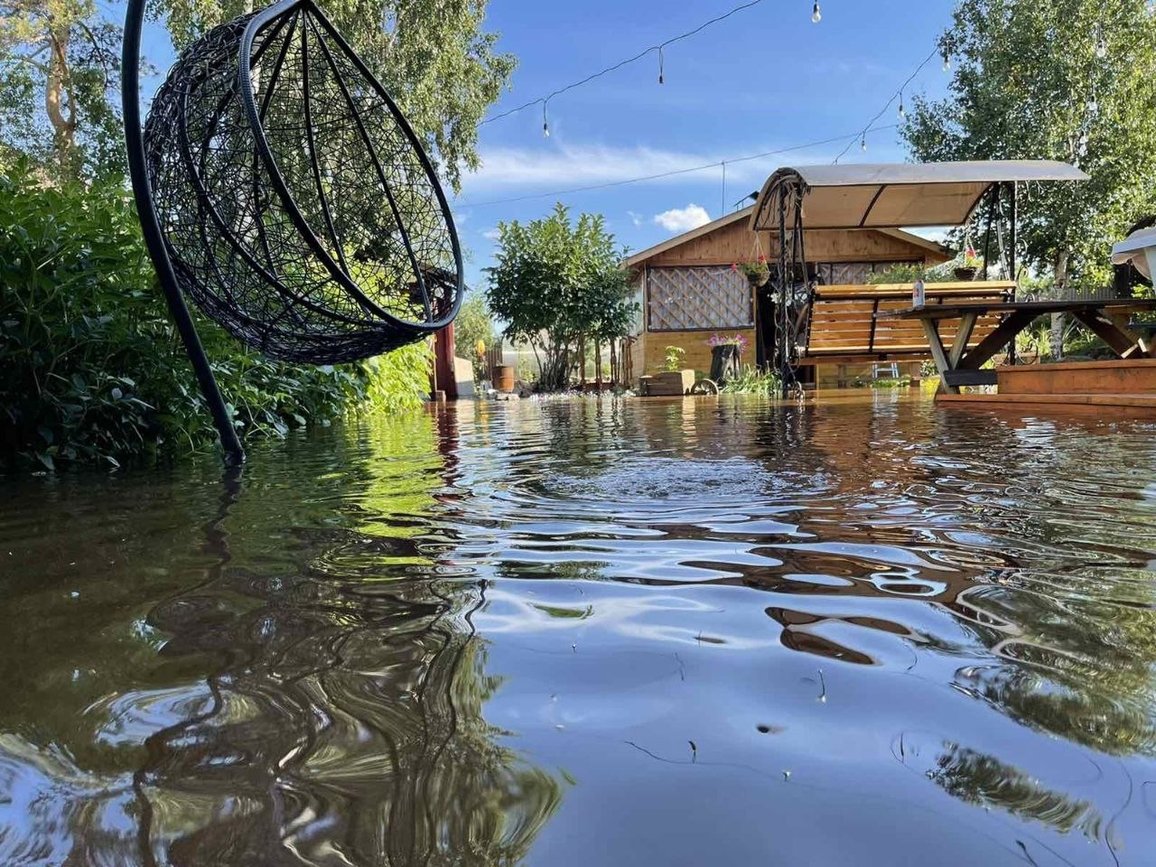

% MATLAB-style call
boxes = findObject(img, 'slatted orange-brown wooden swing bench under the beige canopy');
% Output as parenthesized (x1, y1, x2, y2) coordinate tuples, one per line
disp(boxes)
(800, 281, 1015, 364)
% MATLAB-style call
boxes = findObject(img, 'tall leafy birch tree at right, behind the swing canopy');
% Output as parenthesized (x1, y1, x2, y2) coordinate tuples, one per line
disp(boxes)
(903, 0, 1156, 286)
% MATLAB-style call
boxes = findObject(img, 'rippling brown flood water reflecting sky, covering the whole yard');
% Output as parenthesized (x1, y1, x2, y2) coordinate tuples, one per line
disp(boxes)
(0, 392, 1156, 867)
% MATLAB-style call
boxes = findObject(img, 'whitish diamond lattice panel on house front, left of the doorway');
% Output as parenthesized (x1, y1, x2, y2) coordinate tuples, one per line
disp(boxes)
(646, 265, 754, 331)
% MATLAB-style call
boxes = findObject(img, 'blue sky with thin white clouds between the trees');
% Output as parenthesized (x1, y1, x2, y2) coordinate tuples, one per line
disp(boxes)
(137, 0, 954, 288)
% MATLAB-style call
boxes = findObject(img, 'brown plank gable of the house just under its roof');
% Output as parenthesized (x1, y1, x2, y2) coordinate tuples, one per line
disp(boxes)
(646, 220, 948, 267)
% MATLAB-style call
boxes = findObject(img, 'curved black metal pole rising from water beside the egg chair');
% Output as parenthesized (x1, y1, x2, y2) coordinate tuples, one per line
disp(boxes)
(120, 0, 245, 467)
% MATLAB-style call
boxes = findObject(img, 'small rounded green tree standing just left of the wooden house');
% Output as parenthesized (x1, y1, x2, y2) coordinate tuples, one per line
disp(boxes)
(487, 203, 637, 391)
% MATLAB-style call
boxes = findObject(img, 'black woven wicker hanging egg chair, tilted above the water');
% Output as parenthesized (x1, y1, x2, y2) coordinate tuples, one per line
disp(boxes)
(134, 0, 462, 364)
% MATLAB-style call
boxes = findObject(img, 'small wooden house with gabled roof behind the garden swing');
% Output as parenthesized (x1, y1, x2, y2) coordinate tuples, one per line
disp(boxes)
(627, 206, 953, 387)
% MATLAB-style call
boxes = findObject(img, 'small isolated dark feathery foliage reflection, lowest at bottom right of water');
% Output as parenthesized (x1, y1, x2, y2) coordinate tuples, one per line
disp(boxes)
(927, 743, 1104, 839)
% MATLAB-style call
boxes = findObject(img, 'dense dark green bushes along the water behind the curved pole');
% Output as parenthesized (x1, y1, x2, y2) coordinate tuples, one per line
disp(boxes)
(0, 165, 429, 469)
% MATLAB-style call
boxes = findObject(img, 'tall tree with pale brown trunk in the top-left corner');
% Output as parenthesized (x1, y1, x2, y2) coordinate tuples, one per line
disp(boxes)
(0, 0, 120, 177)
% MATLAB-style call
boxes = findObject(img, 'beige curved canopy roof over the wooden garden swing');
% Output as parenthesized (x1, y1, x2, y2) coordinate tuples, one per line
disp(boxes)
(750, 160, 1088, 231)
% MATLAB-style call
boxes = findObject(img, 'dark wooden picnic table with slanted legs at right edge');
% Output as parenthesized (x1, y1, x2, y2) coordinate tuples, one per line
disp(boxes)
(876, 298, 1156, 394)
